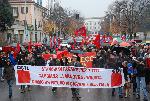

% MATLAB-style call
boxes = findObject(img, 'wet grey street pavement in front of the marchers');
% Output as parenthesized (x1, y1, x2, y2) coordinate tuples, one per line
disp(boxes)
(0, 83, 149, 101)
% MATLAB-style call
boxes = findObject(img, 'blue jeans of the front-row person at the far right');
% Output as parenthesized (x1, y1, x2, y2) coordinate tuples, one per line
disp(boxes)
(136, 77, 147, 99)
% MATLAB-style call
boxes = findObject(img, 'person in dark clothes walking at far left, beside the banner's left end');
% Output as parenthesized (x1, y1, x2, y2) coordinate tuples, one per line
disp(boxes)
(3, 60, 15, 99)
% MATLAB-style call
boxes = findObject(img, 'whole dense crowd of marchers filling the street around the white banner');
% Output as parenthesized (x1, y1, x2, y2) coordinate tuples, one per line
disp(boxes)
(0, 41, 150, 101)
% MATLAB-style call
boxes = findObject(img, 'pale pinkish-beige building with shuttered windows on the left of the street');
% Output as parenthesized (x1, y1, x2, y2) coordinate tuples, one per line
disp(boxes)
(9, 0, 48, 43)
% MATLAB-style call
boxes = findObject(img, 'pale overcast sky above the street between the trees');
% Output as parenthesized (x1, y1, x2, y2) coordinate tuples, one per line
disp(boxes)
(43, 0, 115, 17)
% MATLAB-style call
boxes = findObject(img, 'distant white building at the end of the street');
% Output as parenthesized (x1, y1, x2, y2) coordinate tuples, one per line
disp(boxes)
(84, 17, 102, 34)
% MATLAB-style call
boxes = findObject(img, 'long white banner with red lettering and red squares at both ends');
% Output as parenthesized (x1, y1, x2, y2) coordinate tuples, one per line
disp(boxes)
(14, 65, 124, 88)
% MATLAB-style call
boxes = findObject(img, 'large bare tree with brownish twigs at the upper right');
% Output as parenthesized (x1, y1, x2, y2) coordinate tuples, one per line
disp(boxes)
(101, 0, 150, 39)
